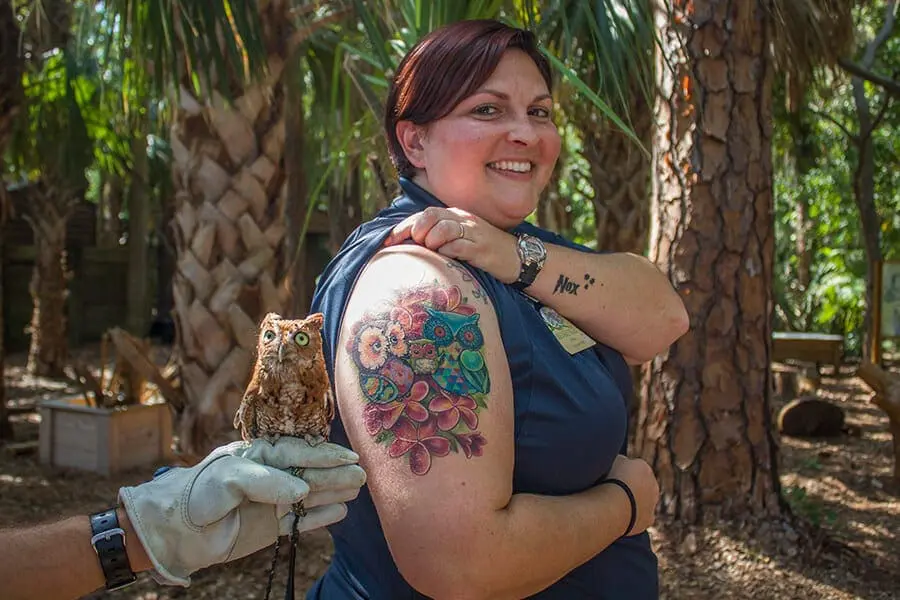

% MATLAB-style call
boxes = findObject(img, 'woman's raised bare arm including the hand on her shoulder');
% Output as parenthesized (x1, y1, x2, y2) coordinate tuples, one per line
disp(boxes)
(387, 208, 689, 363)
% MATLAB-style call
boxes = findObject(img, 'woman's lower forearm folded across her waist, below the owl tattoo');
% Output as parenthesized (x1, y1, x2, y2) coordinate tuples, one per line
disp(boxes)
(398, 485, 631, 600)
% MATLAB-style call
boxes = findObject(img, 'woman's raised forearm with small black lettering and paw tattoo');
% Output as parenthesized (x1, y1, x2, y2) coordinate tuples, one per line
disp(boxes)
(526, 244, 688, 362)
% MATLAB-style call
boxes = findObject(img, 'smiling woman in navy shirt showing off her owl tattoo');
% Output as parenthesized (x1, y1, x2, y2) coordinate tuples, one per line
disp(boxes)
(309, 21, 687, 600)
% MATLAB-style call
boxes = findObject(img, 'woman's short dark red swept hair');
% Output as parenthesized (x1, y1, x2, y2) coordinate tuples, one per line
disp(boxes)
(384, 19, 553, 177)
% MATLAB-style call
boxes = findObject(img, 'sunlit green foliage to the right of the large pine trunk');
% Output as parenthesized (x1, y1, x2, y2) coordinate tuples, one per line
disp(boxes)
(773, 1, 900, 354)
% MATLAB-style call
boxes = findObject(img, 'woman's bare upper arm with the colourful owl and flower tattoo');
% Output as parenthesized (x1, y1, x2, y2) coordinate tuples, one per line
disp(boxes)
(335, 245, 513, 500)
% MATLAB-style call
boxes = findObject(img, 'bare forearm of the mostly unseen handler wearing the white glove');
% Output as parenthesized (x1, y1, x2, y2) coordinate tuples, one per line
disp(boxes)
(0, 509, 152, 600)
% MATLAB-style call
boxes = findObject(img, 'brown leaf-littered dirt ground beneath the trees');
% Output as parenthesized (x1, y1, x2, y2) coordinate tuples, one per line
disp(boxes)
(0, 347, 900, 600)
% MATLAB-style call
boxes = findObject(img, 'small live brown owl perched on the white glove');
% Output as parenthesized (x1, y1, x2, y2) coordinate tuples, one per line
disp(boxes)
(234, 313, 334, 445)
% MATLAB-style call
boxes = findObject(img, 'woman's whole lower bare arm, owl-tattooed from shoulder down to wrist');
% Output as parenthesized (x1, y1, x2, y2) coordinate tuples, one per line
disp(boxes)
(335, 246, 640, 598)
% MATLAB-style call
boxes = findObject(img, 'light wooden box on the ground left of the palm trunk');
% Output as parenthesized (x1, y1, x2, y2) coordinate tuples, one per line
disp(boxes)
(39, 397, 172, 475)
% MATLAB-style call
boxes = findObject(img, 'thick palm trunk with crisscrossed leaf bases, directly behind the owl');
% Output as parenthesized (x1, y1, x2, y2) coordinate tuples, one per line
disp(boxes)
(170, 11, 289, 456)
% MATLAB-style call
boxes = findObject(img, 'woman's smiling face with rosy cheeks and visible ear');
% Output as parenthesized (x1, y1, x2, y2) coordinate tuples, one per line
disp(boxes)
(398, 50, 560, 229)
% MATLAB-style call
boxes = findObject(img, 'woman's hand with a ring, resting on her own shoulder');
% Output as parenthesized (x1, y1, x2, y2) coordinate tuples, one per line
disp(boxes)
(384, 207, 521, 283)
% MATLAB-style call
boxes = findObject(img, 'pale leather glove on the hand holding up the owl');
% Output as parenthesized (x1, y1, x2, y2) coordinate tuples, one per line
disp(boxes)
(119, 437, 366, 587)
